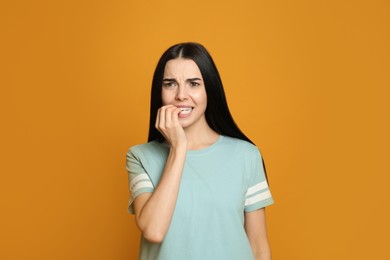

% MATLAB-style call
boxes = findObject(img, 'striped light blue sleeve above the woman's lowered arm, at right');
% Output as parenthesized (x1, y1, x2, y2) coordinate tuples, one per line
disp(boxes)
(244, 149, 274, 212)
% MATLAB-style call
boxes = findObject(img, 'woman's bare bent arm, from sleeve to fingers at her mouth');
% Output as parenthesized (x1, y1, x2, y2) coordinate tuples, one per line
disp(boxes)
(134, 106, 187, 243)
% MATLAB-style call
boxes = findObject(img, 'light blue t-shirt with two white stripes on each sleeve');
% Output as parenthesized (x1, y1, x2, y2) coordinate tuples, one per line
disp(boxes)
(127, 135, 273, 260)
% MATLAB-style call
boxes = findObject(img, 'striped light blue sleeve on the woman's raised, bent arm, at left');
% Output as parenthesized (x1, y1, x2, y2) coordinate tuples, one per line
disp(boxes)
(126, 149, 154, 214)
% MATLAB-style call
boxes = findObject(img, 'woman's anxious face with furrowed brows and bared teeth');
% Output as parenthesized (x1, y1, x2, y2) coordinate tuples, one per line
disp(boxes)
(161, 58, 207, 128)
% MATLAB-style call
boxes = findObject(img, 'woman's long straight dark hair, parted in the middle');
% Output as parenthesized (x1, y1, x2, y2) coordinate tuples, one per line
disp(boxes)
(148, 42, 253, 144)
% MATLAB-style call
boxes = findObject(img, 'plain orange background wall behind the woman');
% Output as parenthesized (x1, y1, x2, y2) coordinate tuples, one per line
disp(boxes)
(0, 0, 390, 260)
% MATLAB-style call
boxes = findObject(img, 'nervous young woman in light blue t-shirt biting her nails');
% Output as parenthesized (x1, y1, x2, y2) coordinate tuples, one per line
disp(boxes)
(127, 43, 273, 260)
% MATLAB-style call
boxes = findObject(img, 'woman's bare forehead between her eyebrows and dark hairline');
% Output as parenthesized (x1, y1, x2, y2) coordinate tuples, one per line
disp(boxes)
(164, 58, 202, 78)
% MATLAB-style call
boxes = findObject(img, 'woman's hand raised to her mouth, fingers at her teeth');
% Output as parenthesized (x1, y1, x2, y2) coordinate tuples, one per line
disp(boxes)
(155, 105, 187, 148)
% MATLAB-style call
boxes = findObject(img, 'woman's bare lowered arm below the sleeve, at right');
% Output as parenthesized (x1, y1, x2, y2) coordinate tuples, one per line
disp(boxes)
(245, 208, 271, 260)
